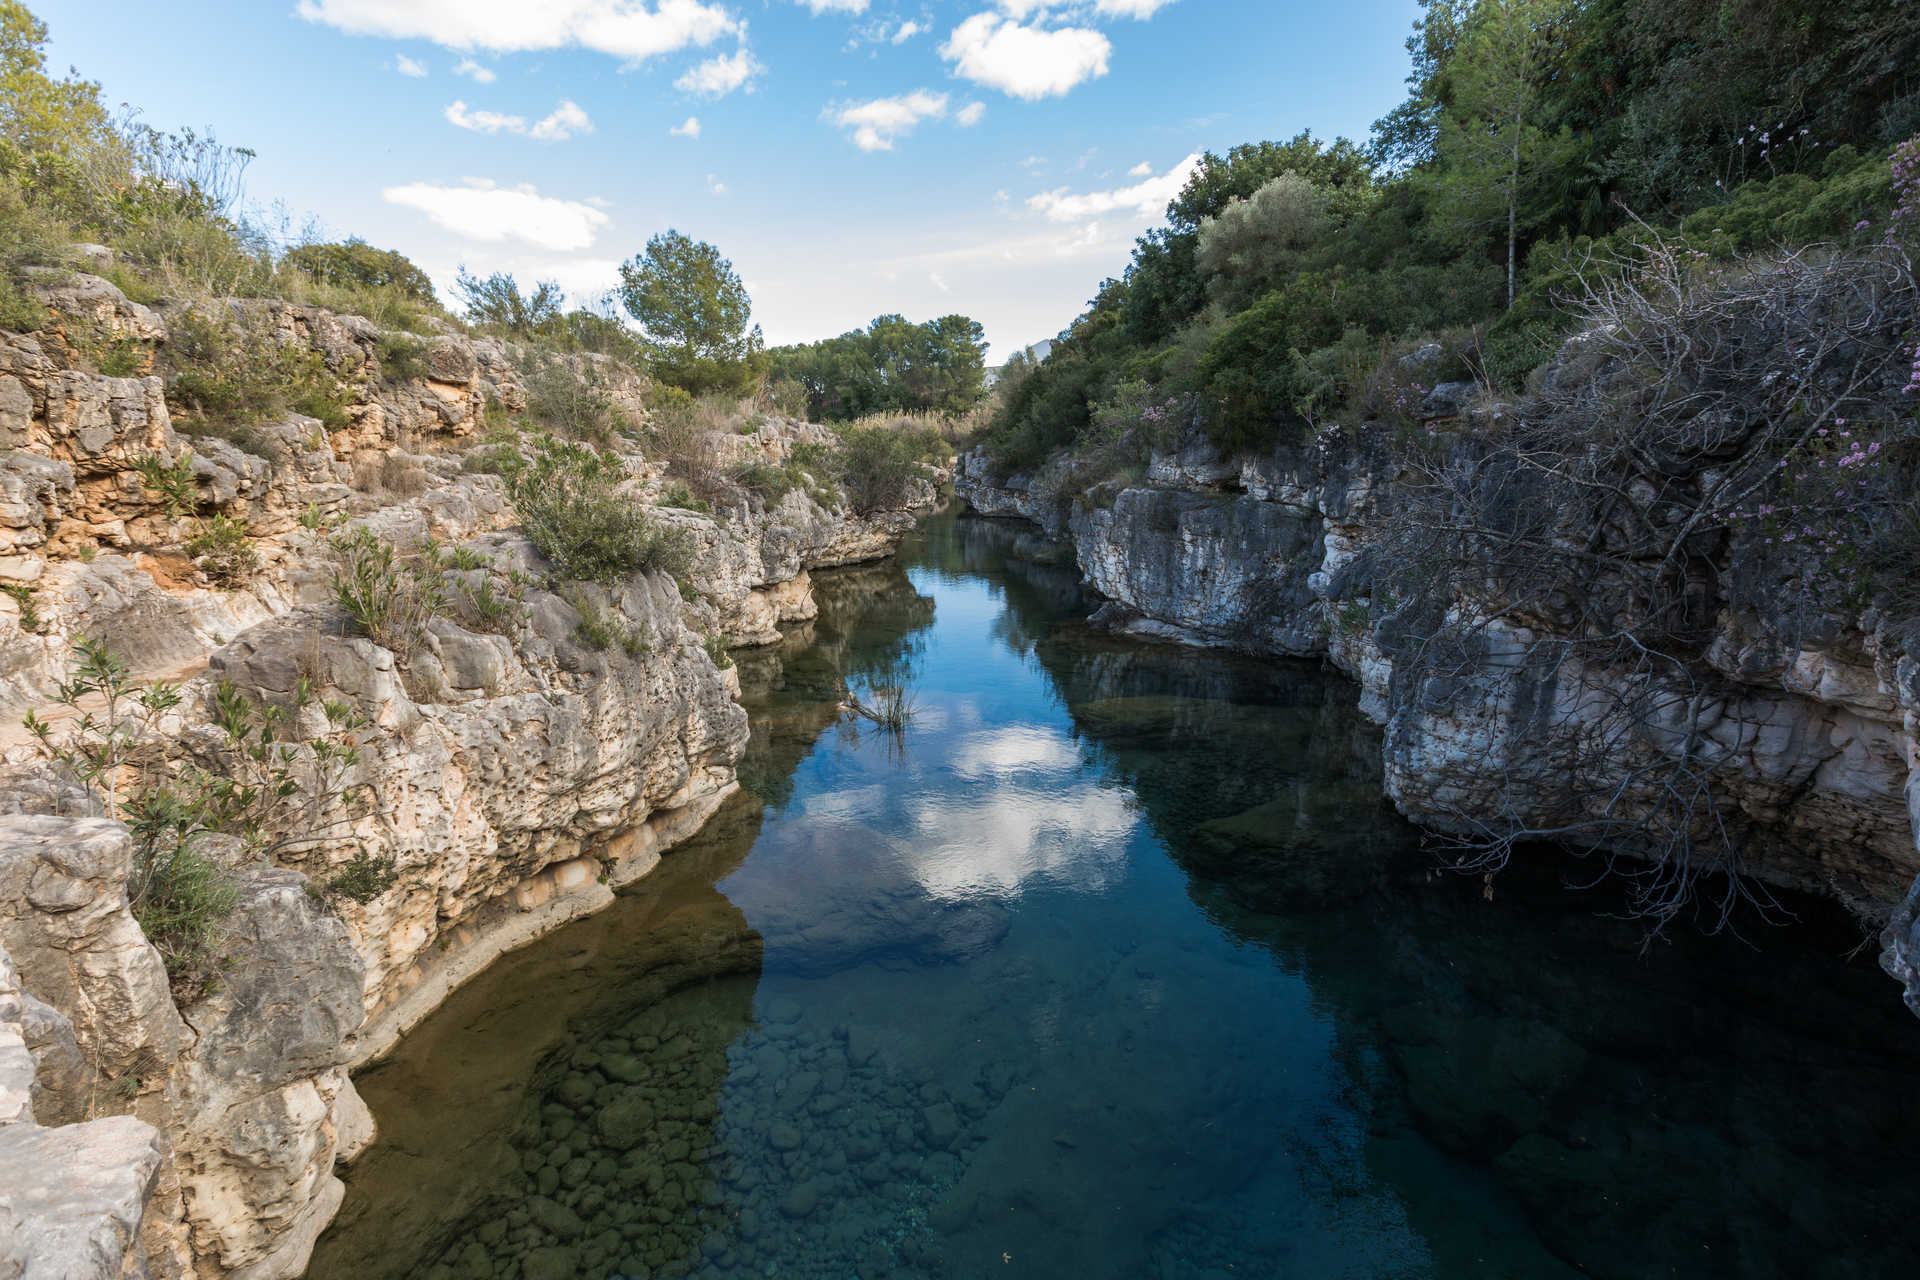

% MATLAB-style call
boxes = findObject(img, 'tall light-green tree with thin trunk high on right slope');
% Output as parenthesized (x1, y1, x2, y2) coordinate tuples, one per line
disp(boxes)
(1427, 0, 1572, 309)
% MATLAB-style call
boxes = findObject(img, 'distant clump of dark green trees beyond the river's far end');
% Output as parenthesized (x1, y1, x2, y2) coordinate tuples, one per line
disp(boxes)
(768, 315, 987, 422)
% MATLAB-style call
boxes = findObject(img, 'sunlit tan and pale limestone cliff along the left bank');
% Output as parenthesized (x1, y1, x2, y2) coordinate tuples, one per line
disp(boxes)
(0, 274, 936, 1280)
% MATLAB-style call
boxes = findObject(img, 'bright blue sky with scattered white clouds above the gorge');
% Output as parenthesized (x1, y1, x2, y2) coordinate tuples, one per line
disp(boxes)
(29, 0, 1417, 359)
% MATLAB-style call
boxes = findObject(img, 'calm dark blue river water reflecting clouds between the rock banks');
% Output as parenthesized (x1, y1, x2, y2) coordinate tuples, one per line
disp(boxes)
(315, 518, 1920, 1280)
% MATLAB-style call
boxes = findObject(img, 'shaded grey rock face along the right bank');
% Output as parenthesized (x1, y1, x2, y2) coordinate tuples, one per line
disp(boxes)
(956, 432, 1920, 1013)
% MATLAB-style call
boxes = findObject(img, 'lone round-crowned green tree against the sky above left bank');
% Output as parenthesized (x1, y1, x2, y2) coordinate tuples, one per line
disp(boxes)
(620, 230, 760, 393)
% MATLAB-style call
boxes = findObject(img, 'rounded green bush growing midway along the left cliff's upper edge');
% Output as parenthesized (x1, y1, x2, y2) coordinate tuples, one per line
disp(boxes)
(505, 434, 693, 583)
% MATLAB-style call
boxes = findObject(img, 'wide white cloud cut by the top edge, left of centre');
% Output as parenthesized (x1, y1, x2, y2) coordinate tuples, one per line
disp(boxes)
(296, 0, 745, 63)
